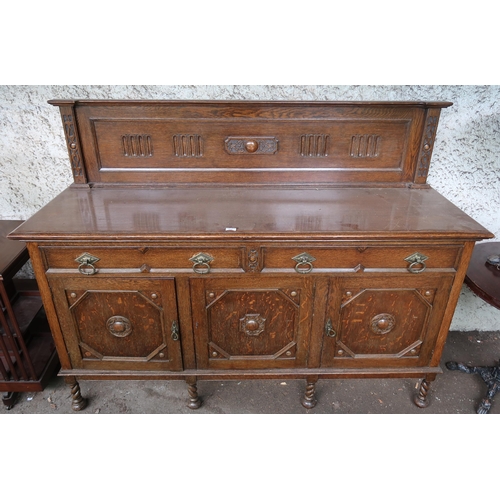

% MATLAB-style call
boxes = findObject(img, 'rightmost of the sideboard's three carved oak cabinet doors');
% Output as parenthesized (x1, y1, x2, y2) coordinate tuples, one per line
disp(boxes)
(321, 276, 453, 368)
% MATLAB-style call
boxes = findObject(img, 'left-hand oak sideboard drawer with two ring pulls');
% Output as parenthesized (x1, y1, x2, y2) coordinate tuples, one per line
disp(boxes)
(41, 246, 244, 274)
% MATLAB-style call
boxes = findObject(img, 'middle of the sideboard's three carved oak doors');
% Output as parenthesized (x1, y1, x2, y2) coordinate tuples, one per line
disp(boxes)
(190, 277, 312, 369)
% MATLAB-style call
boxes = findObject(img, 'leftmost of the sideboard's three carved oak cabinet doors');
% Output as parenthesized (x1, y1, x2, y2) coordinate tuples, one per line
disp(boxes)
(49, 276, 182, 370)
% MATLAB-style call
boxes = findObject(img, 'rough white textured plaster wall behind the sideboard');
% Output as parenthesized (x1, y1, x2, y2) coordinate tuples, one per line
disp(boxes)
(0, 85, 500, 331)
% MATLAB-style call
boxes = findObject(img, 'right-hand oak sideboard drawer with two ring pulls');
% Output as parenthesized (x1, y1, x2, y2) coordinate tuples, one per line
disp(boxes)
(262, 245, 462, 274)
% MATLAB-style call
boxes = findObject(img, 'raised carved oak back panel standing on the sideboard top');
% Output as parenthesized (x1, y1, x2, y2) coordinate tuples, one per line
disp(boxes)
(50, 101, 450, 186)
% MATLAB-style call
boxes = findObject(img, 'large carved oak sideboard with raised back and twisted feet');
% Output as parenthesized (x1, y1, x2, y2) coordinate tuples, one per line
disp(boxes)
(6, 100, 493, 410)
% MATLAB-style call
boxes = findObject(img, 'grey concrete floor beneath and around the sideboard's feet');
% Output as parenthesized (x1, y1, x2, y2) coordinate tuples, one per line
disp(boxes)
(0, 332, 500, 415)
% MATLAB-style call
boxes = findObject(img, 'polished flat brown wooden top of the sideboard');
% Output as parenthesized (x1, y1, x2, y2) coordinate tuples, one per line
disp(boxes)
(11, 187, 492, 241)
